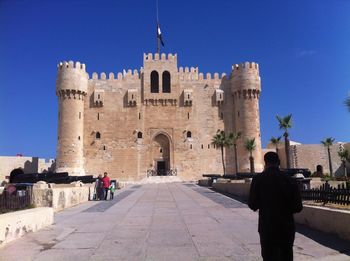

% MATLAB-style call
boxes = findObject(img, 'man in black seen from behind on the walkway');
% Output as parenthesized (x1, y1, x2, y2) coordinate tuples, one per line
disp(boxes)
(248, 152, 303, 261)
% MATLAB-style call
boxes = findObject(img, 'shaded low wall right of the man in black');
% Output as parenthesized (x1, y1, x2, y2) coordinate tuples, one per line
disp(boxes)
(294, 205, 350, 241)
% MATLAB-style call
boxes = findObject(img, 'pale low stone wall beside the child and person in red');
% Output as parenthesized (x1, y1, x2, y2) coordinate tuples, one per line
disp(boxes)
(33, 182, 95, 212)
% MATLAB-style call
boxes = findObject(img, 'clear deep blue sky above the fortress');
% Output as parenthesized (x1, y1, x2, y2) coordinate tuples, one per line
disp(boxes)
(0, 0, 350, 157)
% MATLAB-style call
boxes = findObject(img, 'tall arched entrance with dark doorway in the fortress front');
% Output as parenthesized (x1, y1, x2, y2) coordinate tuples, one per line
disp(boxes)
(152, 133, 171, 176)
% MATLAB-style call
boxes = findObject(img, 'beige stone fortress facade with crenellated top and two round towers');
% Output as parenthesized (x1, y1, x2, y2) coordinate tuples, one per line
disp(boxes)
(56, 54, 263, 181)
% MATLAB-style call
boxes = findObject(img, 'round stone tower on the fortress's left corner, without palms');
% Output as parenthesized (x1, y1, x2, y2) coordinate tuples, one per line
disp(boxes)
(56, 61, 89, 176)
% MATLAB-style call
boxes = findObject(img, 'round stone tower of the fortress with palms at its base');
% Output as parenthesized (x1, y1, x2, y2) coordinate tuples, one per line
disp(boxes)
(231, 62, 264, 172)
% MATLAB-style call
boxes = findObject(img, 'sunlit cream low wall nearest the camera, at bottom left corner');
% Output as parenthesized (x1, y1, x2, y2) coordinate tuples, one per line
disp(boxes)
(0, 208, 54, 247)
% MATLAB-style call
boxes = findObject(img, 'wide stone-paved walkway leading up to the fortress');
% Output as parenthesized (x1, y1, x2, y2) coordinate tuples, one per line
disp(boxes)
(0, 183, 350, 261)
